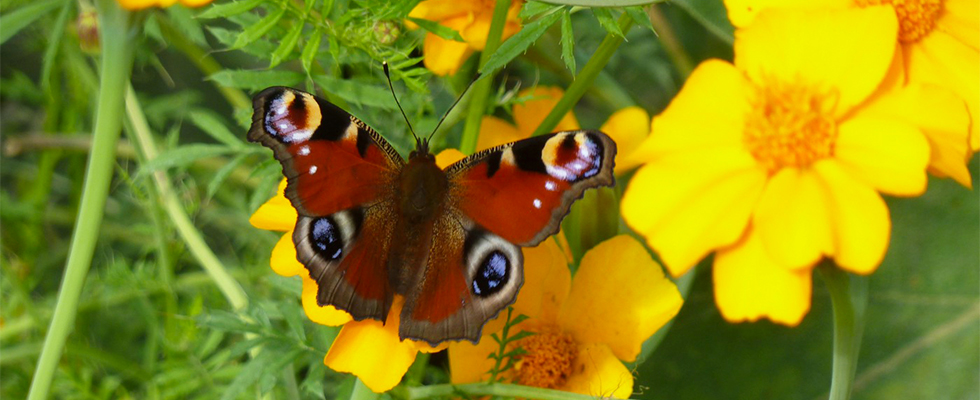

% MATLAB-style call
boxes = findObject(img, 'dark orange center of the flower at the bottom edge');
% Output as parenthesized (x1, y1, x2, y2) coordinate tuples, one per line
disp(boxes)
(514, 331, 578, 389)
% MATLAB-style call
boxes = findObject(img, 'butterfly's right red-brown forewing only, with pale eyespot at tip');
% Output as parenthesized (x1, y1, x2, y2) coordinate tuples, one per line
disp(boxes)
(446, 131, 616, 247)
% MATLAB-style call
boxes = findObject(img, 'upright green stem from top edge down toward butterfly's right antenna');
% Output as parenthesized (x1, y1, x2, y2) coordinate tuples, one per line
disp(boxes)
(459, 0, 510, 154)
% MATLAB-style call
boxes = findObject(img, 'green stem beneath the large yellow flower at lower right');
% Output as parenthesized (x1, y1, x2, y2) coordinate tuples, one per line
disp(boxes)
(818, 263, 868, 400)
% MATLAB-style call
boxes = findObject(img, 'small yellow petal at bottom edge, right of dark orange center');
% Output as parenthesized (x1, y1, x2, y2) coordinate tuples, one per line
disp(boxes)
(559, 343, 633, 399)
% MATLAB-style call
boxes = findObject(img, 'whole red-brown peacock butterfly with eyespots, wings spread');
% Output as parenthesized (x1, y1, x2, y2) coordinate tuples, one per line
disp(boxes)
(248, 87, 616, 346)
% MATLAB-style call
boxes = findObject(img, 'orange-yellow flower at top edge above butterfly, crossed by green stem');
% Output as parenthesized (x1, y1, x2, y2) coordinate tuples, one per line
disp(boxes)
(408, 0, 521, 76)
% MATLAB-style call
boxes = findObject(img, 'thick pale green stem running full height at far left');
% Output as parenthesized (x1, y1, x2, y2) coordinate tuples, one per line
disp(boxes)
(28, 0, 137, 400)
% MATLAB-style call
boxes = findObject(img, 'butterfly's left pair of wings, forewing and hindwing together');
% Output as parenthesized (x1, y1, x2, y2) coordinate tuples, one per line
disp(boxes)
(248, 87, 404, 321)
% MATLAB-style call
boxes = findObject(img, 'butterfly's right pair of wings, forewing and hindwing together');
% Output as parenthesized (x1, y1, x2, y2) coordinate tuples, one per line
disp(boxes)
(400, 131, 616, 344)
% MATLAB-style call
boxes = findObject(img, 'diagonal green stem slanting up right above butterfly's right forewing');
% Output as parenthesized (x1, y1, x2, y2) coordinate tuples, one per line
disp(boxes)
(531, 13, 633, 136)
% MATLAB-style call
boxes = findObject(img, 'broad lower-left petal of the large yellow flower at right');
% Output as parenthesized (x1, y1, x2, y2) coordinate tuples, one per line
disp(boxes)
(621, 147, 767, 276)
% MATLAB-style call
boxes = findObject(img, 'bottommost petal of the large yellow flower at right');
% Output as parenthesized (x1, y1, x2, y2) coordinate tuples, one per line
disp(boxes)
(712, 229, 813, 326)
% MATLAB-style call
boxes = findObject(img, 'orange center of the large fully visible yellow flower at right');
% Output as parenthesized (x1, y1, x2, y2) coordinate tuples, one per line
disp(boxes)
(743, 78, 837, 173)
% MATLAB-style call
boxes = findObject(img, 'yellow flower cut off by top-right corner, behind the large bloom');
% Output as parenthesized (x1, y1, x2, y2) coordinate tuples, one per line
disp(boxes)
(725, 0, 980, 187)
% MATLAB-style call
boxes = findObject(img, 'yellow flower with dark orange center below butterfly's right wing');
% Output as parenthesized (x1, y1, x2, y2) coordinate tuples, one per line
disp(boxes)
(449, 235, 683, 398)
